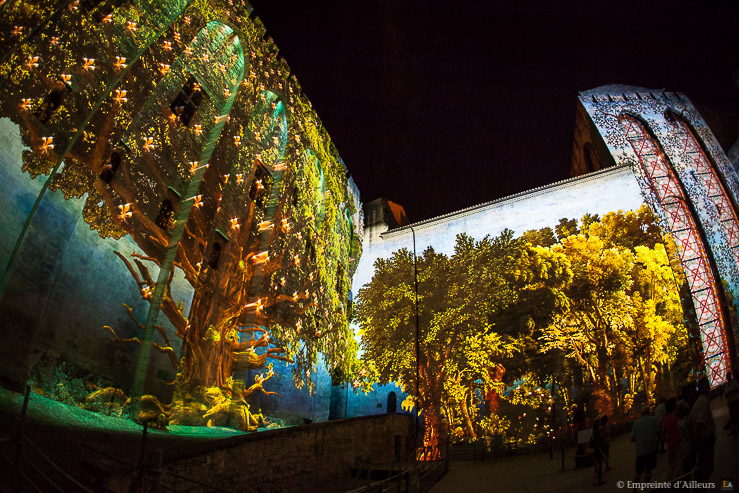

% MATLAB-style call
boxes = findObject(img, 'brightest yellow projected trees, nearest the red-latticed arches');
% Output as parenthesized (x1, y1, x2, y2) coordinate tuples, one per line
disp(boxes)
(541, 207, 687, 414)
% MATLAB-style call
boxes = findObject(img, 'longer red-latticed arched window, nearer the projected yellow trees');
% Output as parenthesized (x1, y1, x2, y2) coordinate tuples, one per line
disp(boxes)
(619, 115, 728, 386)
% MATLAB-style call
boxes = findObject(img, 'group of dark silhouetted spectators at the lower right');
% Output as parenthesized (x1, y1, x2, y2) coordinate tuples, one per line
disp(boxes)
(631, 372, 739, 482)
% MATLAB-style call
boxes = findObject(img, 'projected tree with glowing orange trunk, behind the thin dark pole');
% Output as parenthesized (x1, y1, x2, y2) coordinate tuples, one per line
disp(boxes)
(356, 232, 516, 456)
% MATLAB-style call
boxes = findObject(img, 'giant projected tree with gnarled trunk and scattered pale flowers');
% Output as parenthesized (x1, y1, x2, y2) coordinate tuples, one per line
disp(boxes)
(0, 0, 360, 429)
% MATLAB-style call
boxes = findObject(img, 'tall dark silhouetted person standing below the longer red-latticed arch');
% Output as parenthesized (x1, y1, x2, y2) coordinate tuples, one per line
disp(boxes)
(688, 377, 716, 482)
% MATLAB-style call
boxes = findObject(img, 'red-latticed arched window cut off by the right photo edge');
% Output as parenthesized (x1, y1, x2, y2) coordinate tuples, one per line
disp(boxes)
(665, 111, 739, 264)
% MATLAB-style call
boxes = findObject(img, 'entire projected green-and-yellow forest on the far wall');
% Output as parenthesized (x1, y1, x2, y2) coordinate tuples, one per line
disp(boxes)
(356, 206, 700, 448)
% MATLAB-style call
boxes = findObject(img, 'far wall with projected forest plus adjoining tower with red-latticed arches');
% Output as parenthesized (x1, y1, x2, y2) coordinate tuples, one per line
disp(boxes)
(348, 86, 739, 448)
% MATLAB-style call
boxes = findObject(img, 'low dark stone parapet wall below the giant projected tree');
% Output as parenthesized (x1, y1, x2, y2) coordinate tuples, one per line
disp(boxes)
(162, 414, 413, 492)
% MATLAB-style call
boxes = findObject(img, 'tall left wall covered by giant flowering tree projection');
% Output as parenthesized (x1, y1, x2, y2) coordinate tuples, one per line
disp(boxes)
(0, 0, 362, 422)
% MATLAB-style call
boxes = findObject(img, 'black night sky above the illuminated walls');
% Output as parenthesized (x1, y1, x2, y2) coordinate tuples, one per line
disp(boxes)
(251, 0, 739, 222)
